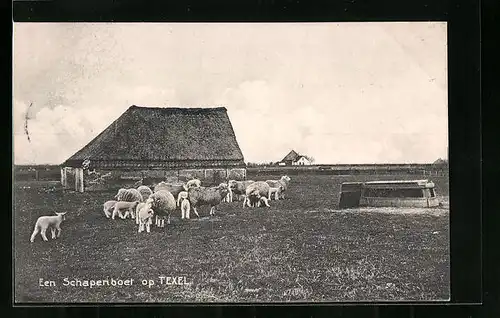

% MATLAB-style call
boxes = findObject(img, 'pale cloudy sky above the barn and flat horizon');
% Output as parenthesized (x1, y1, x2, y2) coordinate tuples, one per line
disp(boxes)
(13, 22, 448, 164)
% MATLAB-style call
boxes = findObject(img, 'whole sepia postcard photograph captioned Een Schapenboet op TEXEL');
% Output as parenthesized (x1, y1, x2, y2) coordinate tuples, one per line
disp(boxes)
(12, 22, 450, 304)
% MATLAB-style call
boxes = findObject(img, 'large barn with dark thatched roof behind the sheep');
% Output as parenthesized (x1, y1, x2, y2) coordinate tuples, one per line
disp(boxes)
(61, 105, 245, 191)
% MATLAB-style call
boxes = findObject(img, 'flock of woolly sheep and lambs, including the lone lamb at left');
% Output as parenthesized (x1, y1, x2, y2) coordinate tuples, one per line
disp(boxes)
(30, 175, 290, 242)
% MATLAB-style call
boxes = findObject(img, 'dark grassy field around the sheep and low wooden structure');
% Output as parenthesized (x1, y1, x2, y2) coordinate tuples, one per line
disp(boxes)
(13, 175, 450, 302)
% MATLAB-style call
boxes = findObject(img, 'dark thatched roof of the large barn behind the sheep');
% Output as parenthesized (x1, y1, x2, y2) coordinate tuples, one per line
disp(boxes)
(63, 105, 244, 166)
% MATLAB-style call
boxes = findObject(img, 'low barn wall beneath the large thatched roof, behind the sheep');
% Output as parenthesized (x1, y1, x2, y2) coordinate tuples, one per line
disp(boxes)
(79, 168, 246, 191)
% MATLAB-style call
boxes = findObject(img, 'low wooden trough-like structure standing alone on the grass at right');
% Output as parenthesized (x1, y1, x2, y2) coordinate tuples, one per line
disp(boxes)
(339, 180, 439, 209)
